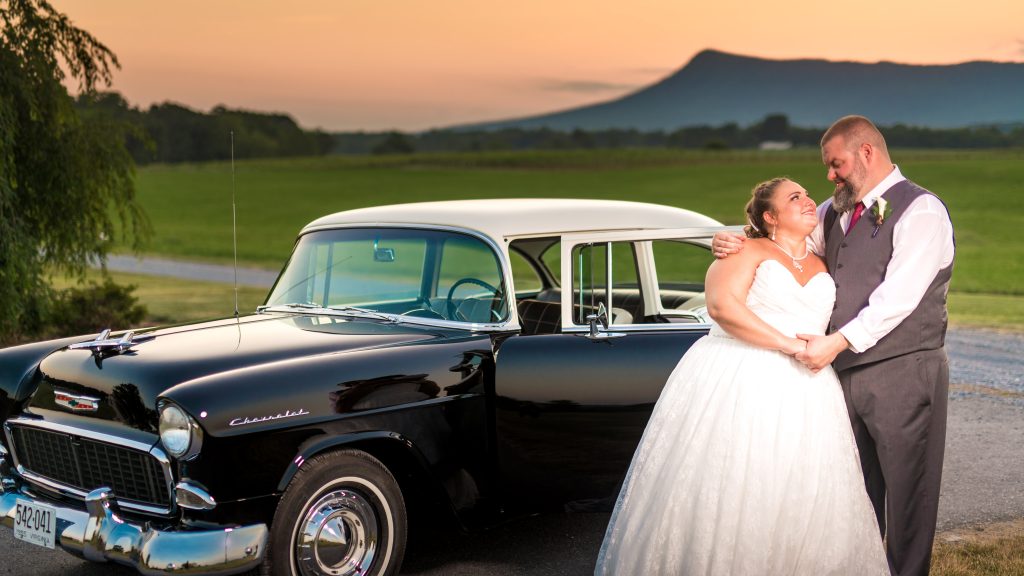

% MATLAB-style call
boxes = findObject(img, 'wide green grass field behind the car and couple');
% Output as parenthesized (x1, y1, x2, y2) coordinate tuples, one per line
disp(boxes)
(110, 150, 1024, 327)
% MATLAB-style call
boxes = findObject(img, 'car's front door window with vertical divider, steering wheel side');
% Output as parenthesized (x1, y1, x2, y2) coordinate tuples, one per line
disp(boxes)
(572, 242, 644, 325)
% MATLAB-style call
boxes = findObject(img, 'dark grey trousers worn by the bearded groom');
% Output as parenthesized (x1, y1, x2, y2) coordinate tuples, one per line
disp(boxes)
(839, 348, 949, 576)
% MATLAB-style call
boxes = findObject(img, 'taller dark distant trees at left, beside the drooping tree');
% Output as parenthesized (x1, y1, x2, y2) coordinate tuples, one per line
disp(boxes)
(76, 92, 334, 164)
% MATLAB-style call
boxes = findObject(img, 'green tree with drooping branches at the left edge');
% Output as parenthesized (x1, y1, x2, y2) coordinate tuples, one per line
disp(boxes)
(0, 0, 150, 342)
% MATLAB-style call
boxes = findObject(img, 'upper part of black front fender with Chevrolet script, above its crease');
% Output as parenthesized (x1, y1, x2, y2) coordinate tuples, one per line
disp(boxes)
(161, 337, 490, 438)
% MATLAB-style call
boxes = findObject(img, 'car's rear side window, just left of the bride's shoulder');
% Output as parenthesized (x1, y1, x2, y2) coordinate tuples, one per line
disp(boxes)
(651, 240, 715, 319)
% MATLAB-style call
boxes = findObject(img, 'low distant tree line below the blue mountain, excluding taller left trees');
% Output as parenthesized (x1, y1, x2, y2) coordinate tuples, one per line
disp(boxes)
(334, 114, 1024, 154)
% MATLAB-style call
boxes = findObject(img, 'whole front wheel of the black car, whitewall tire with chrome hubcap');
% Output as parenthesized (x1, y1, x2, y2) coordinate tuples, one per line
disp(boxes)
(263, 450, 408, 576)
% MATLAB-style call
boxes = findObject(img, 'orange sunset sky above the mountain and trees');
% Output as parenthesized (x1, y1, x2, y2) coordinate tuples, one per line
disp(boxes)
(61, 0, 1024, 130)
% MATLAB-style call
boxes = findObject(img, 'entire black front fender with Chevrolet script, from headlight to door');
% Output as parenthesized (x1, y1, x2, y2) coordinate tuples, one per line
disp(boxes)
(163, 335, 490, 516)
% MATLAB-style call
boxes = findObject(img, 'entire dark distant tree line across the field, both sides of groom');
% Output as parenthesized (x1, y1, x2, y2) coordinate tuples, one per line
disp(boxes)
(76, 92, 1024, 164)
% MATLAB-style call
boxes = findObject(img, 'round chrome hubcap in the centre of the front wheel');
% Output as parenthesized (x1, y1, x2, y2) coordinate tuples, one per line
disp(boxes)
(295, 490, 380, 576)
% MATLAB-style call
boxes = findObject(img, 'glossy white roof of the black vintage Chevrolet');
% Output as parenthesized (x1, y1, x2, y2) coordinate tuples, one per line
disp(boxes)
(302, 198, 722, 240)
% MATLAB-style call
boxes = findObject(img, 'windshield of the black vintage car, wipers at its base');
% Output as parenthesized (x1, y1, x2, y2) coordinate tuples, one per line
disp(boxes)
(262, 229, 509, 324)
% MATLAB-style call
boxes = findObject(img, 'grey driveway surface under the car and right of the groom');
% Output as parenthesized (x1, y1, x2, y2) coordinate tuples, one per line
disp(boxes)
(0, 330, 1024, 576)
